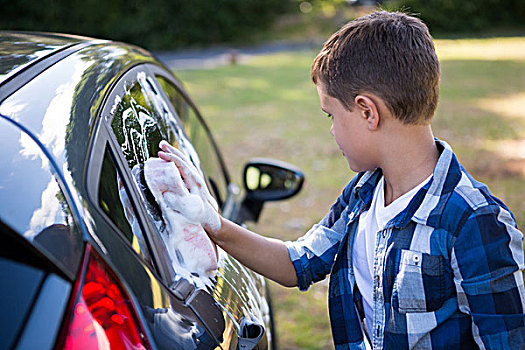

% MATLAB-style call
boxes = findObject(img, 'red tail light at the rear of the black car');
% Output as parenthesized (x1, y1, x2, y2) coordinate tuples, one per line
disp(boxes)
(60, 245, 149, 350)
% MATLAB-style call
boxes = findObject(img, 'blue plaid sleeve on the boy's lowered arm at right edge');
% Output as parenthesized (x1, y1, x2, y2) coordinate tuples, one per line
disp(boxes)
(451, 205, 525, 349)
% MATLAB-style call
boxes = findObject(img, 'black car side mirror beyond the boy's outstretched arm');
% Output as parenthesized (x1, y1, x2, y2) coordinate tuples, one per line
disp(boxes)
(237, 158, 304, 222)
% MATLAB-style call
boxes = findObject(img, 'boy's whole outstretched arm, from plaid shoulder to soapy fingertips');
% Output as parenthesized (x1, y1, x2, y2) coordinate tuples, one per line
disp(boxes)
(158, 141, 359, 290)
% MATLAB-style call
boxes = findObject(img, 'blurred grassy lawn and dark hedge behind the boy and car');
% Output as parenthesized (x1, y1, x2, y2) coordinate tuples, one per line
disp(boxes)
(0, 0, 525, 349)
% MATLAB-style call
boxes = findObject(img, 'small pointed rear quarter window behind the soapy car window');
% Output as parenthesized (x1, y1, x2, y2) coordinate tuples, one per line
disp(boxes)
(98, 148, 153, 266)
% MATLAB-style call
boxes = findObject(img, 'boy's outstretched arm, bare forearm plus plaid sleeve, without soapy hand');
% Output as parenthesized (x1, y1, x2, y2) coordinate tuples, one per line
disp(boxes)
(211, 176, 359, 290)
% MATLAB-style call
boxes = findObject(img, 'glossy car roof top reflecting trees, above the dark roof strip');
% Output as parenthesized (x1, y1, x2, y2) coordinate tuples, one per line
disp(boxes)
(0, 31, 93, 83)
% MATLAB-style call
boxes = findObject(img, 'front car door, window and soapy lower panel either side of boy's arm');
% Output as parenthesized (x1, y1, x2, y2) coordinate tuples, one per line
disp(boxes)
(152, 67, 272, 343)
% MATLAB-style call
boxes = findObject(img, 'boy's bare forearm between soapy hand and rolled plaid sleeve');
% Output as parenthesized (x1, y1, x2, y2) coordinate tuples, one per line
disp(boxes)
(207, 217, 297, 287)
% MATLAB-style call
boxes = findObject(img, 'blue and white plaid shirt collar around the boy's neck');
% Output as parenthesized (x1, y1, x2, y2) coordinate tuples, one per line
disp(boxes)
(355, 139, 461, 228)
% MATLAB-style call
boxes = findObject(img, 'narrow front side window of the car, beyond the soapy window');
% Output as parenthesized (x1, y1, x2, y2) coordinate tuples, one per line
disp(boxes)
(156, 75, 228, 205)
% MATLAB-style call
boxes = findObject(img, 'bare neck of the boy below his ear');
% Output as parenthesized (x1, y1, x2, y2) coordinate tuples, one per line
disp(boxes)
(380, 125, 439, 206)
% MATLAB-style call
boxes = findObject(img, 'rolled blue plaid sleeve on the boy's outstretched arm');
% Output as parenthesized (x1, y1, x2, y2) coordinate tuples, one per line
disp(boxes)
(285, 182, 352, 291)
